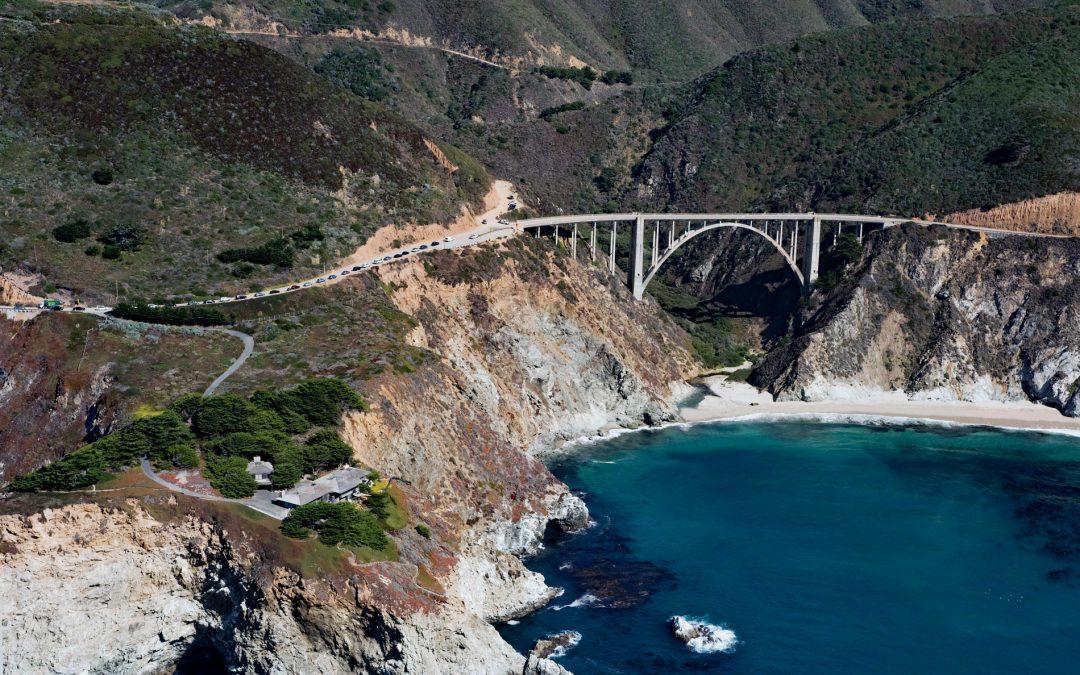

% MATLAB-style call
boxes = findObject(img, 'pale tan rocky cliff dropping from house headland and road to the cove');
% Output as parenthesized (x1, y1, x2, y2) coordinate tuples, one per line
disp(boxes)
(0, 235, 696, 673)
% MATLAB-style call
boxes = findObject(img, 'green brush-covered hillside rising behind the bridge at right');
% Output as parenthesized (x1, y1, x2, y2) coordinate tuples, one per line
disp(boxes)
(629, 8, 1080, 214)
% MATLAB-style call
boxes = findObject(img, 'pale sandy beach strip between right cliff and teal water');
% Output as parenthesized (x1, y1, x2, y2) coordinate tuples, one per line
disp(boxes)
(679, 376, 1080, 436)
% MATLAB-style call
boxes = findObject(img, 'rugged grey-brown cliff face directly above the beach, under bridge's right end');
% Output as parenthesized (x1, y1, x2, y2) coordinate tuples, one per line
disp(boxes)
(751, 226, 1080, 417)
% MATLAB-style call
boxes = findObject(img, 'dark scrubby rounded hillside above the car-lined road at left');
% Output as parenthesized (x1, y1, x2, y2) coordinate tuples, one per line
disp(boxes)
(0, 2, 489, 300)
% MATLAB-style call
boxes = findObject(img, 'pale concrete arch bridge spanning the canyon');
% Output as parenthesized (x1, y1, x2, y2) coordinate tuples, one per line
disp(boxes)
(517, 213, 1042, 299)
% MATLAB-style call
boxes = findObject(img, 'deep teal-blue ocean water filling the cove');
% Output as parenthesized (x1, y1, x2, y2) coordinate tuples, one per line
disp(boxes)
(500, 421, 1080, 675)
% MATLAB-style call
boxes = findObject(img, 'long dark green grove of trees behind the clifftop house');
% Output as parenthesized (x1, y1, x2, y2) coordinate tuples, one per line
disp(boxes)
(11, 378, 365, 498)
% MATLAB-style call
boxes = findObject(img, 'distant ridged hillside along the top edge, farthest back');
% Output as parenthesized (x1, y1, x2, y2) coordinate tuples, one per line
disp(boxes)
(159, 0, 1044, 79)
